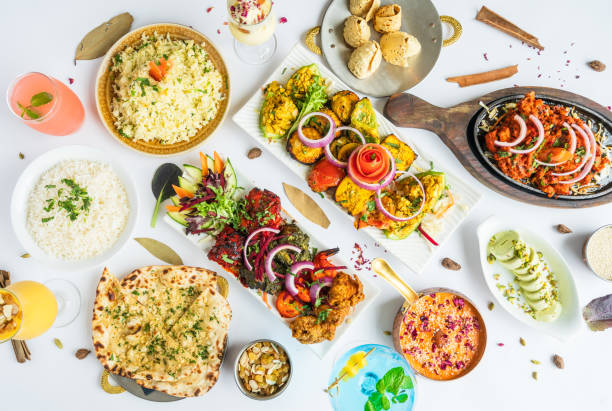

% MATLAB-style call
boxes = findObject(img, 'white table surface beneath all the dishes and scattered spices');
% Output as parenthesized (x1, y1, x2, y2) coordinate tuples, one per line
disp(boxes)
(0, 0, 612, 411)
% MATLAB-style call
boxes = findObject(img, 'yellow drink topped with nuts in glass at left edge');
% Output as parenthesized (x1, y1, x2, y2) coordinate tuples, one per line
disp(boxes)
(0, 281, 58, 343)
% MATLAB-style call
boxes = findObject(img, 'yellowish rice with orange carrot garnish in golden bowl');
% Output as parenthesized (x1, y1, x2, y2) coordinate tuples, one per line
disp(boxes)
(111, 34, 226, 144)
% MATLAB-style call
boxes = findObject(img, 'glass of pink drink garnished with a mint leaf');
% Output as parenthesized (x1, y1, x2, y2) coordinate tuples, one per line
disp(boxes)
(6, 73, 85, 136)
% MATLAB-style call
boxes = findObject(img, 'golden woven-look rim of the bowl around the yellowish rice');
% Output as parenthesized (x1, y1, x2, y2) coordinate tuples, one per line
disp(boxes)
(96, 23, 230, 156)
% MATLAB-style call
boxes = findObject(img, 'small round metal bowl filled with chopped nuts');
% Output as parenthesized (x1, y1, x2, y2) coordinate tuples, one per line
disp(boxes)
(238, 341, 290, 396)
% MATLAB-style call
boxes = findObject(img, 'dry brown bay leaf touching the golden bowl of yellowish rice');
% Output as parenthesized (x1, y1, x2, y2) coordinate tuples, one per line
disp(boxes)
(74, 13, 134, 60)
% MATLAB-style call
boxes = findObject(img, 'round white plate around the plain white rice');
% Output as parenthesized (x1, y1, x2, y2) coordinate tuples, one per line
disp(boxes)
(11, 146, 138, 271)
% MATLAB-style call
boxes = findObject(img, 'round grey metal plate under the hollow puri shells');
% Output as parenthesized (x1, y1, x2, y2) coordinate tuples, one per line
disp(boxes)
(321, 0, 442, 97)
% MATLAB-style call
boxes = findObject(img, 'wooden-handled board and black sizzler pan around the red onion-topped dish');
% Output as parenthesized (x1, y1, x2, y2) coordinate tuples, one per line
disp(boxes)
(384, 87, 612, 208)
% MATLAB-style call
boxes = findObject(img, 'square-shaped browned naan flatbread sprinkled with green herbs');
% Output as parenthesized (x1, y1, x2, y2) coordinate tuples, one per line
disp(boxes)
(92, 266, 231, 397)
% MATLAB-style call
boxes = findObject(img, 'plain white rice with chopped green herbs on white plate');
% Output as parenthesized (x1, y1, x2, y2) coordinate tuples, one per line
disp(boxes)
(26, 160, 130, 261)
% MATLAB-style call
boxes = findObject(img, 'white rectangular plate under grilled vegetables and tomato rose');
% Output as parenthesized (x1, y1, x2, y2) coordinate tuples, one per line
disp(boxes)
(233, 44, 480, 274)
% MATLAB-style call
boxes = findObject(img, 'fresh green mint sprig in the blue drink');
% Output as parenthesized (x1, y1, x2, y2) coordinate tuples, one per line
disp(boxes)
(364, 367, 414, 411)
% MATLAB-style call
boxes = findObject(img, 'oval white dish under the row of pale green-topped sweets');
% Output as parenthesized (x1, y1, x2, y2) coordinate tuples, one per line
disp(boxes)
(477, 216, 582, 341)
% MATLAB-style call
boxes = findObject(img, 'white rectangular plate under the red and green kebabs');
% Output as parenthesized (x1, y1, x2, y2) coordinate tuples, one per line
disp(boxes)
(164, 158, 380, 358)
